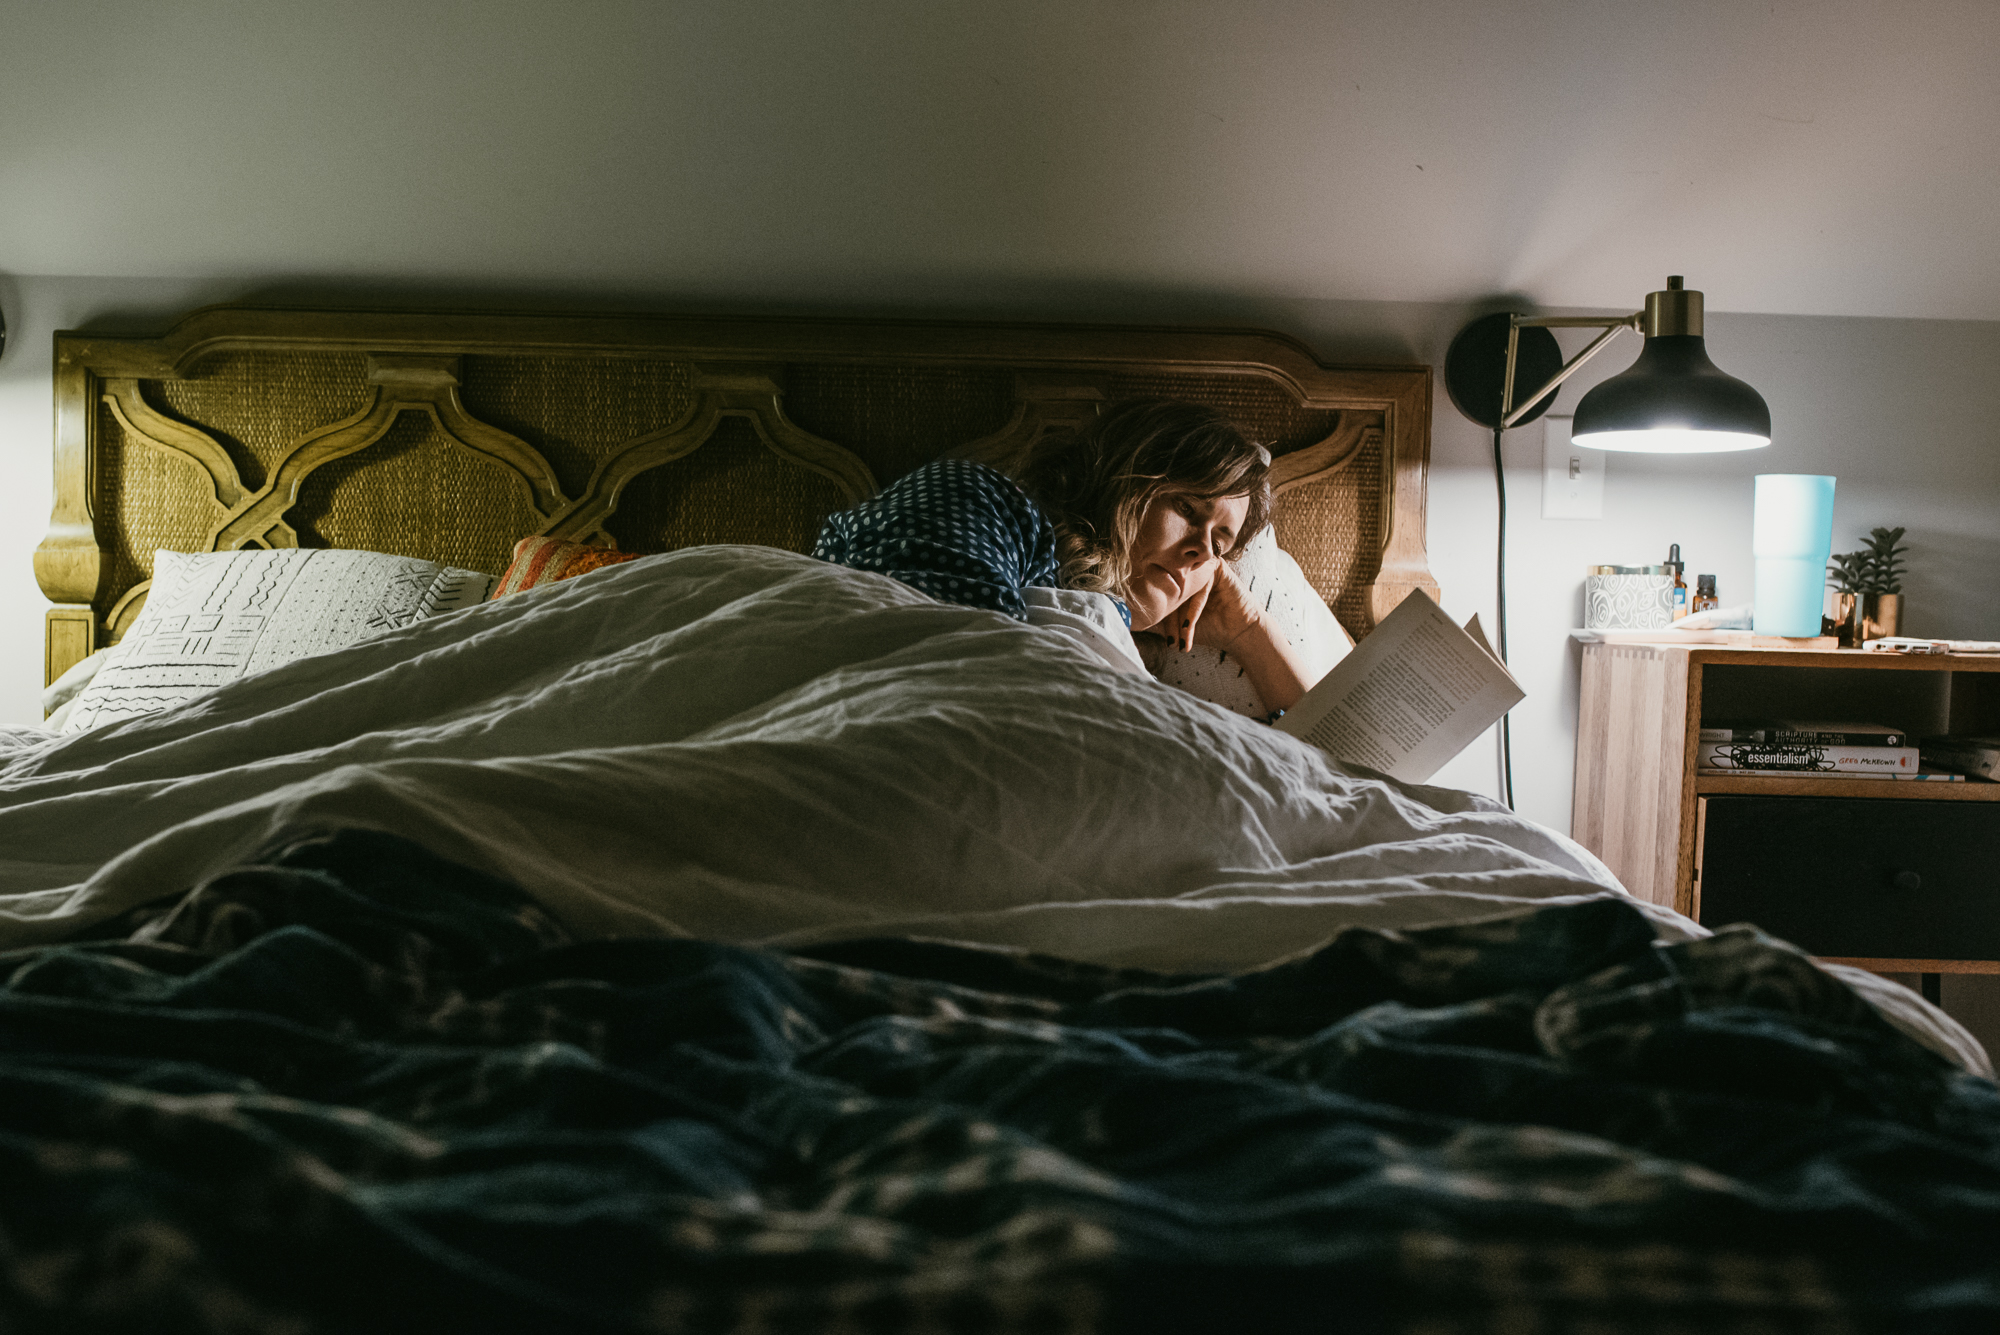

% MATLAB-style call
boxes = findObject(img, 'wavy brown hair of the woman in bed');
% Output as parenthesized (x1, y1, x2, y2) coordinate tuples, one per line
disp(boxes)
(1020, 398, 1270, 594)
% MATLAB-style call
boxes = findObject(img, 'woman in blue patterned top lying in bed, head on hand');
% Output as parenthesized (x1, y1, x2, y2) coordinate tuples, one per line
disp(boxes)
(814, 400, 1310, 711)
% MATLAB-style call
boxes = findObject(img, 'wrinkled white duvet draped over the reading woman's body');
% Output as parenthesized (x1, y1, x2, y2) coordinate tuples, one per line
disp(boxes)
(0, 548, 1982, 1067)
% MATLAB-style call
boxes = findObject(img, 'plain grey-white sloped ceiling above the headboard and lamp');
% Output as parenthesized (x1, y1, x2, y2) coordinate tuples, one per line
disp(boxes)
(0, 0, 2000, 320)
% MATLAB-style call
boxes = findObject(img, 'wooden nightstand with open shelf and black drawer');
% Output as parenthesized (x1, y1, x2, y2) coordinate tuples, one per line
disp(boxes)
(1570, 644, 2000, 991)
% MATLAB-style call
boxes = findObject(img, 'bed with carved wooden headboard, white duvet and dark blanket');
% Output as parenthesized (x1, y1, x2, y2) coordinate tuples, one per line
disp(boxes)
(11, 308, 2000, 1331)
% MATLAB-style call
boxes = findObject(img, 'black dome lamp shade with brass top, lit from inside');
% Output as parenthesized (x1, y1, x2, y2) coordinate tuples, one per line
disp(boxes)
(1570, 278, 1770, 454)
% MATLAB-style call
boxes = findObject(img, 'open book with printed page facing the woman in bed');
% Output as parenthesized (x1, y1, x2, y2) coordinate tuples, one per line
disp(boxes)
(1278, 594, 1526, 783)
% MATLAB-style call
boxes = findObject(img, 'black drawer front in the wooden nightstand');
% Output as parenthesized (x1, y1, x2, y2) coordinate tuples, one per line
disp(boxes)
(1698, 803, 2000, 959)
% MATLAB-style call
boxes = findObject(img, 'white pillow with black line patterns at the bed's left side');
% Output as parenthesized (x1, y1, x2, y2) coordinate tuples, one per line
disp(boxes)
(62, 548, 494, 733)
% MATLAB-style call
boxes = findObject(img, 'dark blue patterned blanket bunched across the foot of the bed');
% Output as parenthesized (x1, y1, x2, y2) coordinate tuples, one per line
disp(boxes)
(0, 833, 2000, 1335)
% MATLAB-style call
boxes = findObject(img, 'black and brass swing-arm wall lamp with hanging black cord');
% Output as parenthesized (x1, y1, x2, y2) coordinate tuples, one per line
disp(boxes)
(1444, 276, 1770, 807)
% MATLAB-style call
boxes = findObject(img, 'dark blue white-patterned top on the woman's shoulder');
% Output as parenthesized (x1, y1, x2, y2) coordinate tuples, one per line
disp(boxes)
(812, 460, 1130, 622)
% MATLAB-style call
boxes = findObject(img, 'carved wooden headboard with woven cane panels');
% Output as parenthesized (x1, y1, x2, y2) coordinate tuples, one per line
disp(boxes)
(34, 308, 1436, 679)
